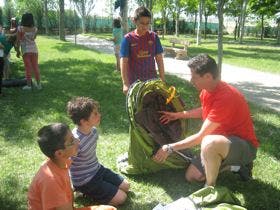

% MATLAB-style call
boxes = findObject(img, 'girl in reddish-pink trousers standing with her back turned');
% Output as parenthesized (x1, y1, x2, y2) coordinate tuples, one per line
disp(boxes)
(17, 13, 42, 90)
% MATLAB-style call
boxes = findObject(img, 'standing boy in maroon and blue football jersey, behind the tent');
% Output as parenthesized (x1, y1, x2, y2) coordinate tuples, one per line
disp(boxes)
(120, 6, 165, 94)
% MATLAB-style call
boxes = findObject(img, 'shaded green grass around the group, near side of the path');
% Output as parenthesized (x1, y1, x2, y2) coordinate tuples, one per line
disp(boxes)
(0, 37, 280, 210)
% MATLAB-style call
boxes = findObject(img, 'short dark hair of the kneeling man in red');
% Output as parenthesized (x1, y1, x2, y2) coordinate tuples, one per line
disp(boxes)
(188, 54, 219, 79)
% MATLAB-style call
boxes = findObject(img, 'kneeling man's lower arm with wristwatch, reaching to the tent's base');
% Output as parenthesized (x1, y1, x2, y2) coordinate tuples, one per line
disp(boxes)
(153, 119, 220, 162)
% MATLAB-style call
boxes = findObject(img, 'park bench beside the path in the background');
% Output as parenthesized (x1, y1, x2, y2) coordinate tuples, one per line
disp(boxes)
(164, 38, 190, 60)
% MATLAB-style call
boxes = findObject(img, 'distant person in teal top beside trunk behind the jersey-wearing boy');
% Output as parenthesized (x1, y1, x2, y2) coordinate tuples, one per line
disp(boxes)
(113, 18, 123, 71)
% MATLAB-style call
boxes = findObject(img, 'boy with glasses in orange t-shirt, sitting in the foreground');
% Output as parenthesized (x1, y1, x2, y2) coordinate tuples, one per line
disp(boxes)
(27, 123, 116, 210)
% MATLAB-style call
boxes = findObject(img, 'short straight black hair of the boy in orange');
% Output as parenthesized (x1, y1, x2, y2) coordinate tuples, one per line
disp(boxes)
(38, 123, 69, 159)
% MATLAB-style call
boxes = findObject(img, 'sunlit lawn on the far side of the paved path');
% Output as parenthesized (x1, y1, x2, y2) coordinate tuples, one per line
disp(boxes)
(86, 33, 280, 74)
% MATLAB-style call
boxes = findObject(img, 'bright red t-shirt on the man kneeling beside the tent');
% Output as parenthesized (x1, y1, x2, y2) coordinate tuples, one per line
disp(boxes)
(200, 82, 259, 147)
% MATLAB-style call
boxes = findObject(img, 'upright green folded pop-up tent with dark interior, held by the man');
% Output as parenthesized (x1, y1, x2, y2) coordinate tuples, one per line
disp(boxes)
(118, 79, 191, 174)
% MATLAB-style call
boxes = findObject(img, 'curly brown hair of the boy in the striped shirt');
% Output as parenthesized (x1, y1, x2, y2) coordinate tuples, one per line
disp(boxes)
(67, 97, 99, 125)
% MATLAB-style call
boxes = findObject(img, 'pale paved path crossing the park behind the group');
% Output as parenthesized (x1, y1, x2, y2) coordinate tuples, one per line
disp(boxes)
(66, 35, 280, 112)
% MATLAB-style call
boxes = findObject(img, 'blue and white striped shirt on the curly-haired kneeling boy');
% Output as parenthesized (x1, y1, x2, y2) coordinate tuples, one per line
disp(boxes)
(70, 128, 101, 186)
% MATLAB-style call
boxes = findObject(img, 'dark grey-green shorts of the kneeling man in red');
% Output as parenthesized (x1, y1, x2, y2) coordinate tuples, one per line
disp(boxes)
(191, 136, 257, 175)
